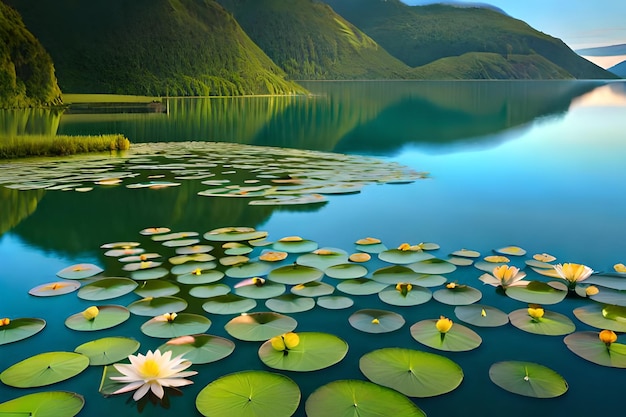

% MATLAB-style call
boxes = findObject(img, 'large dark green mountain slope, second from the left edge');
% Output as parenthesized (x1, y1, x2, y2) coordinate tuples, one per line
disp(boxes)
(4, 0, 304, 95)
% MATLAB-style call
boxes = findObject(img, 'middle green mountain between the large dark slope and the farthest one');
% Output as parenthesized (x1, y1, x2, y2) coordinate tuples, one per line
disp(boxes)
(218, 0, 409, 80)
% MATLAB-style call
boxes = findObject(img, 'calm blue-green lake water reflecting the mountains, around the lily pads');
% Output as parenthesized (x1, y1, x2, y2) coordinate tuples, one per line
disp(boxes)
(0, 81, 626, 417)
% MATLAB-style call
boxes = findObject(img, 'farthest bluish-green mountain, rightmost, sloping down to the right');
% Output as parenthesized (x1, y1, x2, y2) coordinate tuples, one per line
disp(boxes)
(324, 0, 616, 79)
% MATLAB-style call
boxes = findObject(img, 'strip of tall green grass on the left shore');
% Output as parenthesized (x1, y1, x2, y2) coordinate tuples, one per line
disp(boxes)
(0, 134, 130, 159)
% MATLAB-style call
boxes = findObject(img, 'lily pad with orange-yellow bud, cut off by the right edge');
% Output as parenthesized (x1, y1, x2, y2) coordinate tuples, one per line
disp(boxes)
(563, 332, 626, 368)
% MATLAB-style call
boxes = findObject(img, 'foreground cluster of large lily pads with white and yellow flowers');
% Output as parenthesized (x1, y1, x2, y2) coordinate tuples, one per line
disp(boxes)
(0, 227, 626, 417)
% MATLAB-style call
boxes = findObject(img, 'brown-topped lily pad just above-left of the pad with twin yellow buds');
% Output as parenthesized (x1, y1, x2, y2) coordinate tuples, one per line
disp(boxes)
(224, 312, 298, 342)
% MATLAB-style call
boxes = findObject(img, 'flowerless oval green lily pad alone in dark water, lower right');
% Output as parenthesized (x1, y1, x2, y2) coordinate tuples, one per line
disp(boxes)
(489, 361, 568, 398)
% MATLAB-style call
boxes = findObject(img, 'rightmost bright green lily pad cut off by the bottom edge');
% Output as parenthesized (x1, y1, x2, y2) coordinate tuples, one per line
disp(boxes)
(305, 380, 426, 417)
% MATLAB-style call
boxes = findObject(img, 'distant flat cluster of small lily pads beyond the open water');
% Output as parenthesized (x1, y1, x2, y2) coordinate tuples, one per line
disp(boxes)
(0, 142, 427, 205)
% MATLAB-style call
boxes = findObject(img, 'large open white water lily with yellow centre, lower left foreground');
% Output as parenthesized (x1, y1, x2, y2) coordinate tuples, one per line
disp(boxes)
(111, 349, 197, 401)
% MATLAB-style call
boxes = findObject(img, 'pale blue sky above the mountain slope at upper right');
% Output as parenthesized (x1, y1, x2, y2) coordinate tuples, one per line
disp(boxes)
(402, 0, 626, 49)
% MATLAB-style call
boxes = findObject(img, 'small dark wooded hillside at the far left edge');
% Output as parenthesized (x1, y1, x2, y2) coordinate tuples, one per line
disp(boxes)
(0, 2, 61, 108)
